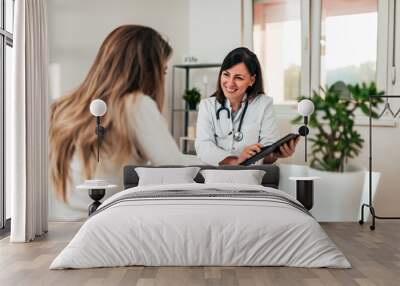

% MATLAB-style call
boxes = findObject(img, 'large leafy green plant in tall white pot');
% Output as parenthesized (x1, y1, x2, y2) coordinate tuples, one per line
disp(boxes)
(292, 81, 383, 221)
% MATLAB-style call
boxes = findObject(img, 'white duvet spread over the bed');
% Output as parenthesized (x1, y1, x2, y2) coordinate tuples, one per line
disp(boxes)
(50, 184, 350, 269)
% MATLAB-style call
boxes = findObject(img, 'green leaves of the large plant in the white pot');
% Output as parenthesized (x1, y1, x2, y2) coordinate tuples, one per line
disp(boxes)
(292, 81, 383, 172)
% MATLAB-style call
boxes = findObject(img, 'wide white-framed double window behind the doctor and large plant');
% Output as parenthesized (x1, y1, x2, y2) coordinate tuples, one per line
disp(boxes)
(252, 0, 384, 106)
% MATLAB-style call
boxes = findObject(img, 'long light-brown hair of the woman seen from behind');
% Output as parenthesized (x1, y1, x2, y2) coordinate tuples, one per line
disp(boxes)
(49, 25, 172, 202)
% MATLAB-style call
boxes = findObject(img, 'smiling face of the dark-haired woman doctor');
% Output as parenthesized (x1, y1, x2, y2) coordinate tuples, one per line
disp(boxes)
(220, 63, 256, 105)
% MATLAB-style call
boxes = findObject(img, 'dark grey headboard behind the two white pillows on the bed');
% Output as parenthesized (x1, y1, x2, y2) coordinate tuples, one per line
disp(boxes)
(123, 165, 279, 190)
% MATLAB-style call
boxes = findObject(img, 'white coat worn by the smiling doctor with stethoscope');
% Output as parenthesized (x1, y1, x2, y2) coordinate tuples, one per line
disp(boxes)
(195, 94, 279, 165)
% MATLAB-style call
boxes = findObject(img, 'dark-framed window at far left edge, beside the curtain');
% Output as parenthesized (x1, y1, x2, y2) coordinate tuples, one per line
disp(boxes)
(0, 0, 14, 231)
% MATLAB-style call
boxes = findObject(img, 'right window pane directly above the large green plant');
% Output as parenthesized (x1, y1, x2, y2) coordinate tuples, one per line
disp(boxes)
(320, 0, 378, 86)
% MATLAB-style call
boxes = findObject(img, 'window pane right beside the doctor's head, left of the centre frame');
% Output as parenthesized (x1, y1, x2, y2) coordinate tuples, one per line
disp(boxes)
(253, 0, 301, 103)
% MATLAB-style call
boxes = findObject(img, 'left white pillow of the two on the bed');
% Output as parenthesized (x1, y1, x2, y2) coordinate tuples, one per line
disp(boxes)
(135, 167, 200, 186)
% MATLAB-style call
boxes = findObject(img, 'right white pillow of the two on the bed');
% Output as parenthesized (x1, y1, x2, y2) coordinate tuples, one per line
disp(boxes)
(200, 170, 265, 185)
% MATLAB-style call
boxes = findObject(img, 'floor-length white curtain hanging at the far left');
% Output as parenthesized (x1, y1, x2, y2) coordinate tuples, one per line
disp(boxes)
(6, 0, 48, 242)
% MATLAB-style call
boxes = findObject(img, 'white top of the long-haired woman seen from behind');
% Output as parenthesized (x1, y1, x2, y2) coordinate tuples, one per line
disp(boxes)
(49, 95, 201, 221)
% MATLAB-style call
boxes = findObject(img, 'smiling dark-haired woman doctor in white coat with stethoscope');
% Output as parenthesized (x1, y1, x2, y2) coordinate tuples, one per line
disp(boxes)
(195, 48, 298, 165)
